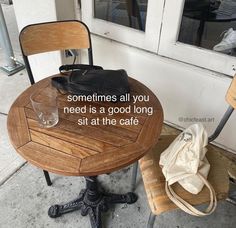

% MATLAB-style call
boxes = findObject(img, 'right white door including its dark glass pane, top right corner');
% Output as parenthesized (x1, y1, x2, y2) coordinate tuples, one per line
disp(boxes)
(158, 0, 236, 75)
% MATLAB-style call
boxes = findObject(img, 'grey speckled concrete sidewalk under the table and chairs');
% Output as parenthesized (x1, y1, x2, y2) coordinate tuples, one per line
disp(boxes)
(0, 5, 236, 228)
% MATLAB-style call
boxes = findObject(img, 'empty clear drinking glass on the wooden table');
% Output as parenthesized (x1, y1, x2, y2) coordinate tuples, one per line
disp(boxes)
(30, 88, 59, 128)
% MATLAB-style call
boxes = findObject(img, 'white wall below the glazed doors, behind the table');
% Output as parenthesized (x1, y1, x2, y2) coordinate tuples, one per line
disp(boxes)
(83, 35, 236, 151)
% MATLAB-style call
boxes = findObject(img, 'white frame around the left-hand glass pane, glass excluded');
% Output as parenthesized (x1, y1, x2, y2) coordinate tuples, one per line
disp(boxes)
(81, 0, 165, 53)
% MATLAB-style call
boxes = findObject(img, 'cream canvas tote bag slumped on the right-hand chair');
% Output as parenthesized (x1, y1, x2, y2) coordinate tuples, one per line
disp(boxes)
(159, 124, 217, 216)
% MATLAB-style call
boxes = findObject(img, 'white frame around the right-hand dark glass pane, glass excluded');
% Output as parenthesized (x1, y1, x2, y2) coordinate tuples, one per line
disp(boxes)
(158, 0, 236, 75)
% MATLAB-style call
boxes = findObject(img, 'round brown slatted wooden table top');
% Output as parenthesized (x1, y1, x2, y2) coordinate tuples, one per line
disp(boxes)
(7, 77, 163, 176)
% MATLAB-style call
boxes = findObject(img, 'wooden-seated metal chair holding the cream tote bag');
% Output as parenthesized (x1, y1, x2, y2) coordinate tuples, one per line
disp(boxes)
(136, 77, 236, 228)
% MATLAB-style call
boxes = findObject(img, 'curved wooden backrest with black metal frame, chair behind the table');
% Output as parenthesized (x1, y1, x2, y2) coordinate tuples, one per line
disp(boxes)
(19, 20, 93, 84)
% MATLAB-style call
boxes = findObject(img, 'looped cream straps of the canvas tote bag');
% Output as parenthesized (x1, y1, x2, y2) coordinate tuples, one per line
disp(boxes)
(165, 173, 217, 216)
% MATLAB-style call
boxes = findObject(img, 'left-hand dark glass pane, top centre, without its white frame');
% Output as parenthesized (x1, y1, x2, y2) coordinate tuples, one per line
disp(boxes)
(94, 0, 148, 31)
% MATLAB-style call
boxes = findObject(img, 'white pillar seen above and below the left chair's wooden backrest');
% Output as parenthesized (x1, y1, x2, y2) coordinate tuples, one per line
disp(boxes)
(13, 0, 75, 81)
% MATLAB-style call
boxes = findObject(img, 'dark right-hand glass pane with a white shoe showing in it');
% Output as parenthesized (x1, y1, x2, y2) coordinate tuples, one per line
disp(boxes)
(178, 0, 236, 56)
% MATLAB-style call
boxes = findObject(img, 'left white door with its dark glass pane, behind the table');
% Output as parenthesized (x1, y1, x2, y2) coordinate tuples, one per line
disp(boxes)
(81, 0, 164, 53)
